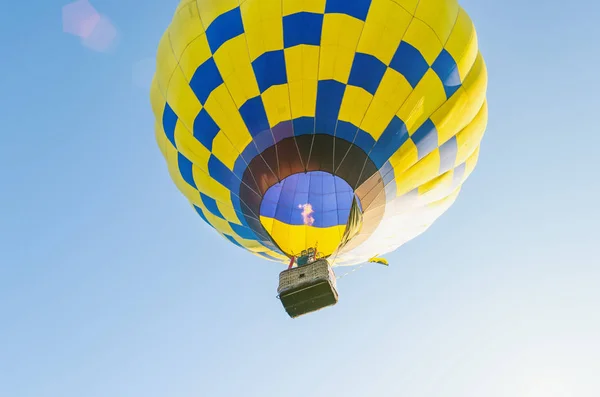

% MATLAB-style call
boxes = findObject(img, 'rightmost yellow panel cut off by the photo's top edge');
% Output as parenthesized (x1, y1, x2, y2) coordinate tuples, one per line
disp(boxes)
(415, 0, 459, 43)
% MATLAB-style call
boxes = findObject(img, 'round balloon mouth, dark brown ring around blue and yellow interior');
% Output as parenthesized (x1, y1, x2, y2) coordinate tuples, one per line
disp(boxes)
(238, 135, 389, 257)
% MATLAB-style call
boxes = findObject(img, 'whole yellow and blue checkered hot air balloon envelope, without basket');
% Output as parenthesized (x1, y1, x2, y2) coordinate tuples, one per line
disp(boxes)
(151, 0, 487, 265)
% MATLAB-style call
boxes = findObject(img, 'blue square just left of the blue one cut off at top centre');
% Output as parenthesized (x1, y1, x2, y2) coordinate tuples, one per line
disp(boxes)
(283, 12, 323, 48)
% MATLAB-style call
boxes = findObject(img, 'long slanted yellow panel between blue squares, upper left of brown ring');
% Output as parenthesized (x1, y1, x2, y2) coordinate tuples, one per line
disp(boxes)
(204, 84, 252, 154)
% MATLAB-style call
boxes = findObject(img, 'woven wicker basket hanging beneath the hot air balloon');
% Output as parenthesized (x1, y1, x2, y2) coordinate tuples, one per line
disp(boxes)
(277, 259, 338, 318)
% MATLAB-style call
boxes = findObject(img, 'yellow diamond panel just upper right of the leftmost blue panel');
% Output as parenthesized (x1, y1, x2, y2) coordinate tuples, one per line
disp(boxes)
(167, 68, 202, 131)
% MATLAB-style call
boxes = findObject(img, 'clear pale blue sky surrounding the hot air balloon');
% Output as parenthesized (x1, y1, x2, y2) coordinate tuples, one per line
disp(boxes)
(0, 0, 600, 397)
